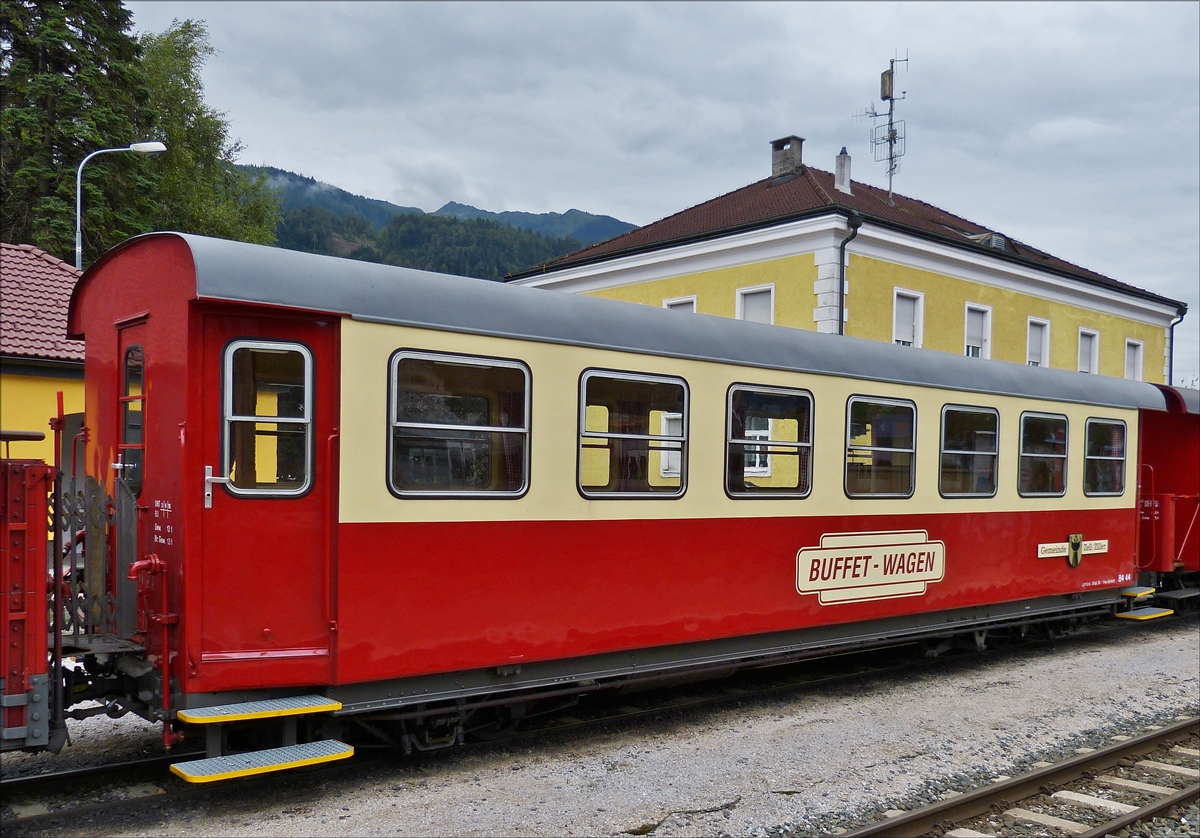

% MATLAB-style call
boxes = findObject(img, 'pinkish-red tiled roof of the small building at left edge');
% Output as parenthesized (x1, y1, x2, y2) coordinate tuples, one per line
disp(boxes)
(0, 243, 83, 361)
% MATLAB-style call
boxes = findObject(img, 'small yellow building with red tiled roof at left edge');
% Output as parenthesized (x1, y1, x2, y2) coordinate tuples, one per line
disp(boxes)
(0, 243, 83, 462)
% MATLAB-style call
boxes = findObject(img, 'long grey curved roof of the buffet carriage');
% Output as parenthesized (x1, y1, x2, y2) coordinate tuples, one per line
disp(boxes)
(124, 233, 1166, 409)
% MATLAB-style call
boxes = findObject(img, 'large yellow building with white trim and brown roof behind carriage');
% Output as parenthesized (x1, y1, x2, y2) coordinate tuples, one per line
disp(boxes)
(509, 136, 1187, 382)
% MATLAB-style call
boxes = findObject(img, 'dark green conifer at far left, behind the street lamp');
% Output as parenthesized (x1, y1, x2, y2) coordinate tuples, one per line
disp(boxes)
(0, 0, 152, 261)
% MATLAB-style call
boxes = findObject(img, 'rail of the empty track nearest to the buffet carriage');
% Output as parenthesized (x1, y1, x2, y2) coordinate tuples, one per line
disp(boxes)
(844, 717, 1200, 838)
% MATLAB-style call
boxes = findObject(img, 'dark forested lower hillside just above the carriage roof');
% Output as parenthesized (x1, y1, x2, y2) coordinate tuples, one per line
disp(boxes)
(278, 206, 580, 280)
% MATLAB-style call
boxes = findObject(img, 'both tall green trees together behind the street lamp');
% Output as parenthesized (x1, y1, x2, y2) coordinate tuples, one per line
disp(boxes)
(0, 0, 278, 263)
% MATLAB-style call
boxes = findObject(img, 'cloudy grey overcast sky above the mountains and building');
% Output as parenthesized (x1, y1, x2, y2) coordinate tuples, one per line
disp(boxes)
(128, 2, 1200, 381)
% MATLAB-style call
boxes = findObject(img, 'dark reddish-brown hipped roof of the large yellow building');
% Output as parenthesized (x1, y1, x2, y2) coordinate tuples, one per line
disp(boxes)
(510, 166, 1184, 309)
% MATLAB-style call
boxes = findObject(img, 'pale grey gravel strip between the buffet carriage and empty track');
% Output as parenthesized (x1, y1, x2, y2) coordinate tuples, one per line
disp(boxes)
(5, 618, 1200, 837)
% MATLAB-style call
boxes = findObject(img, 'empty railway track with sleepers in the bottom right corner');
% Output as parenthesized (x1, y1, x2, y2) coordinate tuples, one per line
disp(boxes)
(845, 718, 1200, 838)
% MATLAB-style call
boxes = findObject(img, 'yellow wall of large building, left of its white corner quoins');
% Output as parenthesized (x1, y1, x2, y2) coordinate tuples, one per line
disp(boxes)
(590, 253, 817, 329)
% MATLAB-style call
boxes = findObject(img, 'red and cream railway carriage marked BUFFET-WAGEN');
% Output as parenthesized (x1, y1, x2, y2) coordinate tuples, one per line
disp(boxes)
(4, 233, 1200, 779)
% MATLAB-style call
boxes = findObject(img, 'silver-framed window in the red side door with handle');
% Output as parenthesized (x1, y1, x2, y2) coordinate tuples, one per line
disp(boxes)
(224, 341, 312, 496)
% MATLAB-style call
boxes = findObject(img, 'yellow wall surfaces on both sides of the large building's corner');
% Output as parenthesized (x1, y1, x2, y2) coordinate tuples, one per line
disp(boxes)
(588, 248, 1165, 382)
